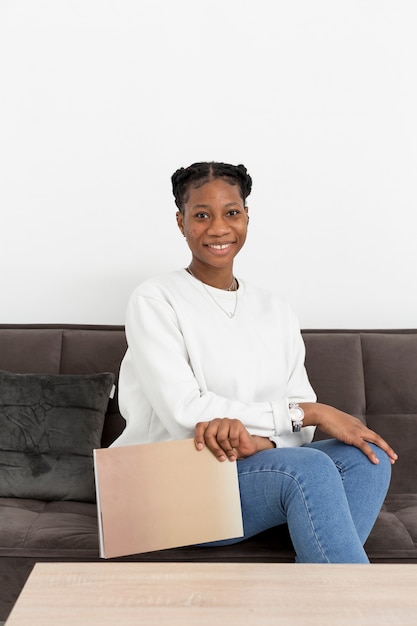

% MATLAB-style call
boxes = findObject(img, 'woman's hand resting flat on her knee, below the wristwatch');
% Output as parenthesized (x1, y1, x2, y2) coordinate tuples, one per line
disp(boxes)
(300, 403, 398, 463)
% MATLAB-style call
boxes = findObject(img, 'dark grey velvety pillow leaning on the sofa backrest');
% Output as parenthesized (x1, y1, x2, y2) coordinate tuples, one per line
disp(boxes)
(0, 371, 115, 502)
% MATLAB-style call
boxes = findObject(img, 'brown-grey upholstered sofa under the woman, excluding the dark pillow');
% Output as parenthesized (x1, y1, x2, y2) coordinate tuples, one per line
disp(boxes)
(0, 325, 417, 621)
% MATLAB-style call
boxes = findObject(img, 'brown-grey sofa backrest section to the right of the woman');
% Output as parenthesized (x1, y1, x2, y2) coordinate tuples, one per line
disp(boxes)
(303, 329, 417, 493)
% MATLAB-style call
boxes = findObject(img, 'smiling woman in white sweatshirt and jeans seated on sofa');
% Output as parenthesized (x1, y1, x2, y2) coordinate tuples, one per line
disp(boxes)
(116, 163, 397, 563)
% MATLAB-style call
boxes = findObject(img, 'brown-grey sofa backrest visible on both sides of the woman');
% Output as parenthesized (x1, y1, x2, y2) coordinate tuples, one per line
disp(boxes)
(0, 324, 417, 493)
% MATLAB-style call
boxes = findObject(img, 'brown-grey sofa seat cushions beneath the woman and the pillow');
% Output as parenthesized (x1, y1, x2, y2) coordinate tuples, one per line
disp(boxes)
(0, 493, 417, 569)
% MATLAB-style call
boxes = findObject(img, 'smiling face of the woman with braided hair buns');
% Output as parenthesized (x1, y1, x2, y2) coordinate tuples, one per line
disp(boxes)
(177, 178, 248, 269)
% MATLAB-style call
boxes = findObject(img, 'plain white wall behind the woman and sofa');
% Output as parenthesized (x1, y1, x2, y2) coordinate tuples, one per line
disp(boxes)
(0, 0, 417, 328)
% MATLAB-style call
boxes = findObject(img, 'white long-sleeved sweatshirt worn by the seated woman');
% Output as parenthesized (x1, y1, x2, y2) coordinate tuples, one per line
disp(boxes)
(113, 269, 316, 447)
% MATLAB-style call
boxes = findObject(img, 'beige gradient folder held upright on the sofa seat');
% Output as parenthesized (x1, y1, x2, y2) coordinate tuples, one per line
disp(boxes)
(94, 439, 243, 558)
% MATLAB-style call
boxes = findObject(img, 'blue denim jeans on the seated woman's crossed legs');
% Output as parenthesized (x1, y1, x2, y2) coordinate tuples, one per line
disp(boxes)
(205, 439, 391, 563)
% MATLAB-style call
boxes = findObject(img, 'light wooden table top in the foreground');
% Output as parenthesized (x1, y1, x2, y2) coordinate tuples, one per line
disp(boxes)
(6, 561, 417, 626)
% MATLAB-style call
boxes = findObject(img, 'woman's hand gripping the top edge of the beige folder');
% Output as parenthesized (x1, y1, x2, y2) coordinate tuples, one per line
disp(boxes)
(194, 417, 274, 461)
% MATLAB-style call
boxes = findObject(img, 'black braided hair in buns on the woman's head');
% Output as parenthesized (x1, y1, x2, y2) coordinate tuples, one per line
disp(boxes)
(171, 161, 252, 213)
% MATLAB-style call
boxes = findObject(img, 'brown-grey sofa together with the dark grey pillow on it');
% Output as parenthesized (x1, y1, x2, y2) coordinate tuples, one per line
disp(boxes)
(0, 324, 417, 621)
